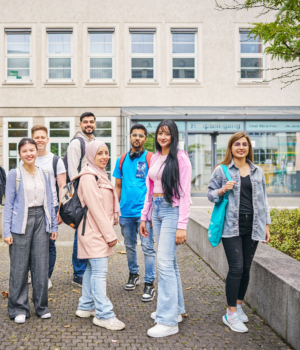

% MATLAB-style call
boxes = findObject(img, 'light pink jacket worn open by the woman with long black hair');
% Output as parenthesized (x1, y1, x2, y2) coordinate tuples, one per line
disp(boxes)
(141, 150, 192, 230)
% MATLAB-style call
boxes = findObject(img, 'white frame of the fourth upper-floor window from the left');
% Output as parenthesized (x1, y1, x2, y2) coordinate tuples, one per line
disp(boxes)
(129, 28, 157, 83)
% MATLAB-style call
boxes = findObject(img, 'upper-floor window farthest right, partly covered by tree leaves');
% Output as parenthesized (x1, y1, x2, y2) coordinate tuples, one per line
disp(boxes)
(240, 29, 265, 80)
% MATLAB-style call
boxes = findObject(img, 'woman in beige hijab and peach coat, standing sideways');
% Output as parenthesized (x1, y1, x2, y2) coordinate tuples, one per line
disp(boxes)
(72, 141, 125, 330)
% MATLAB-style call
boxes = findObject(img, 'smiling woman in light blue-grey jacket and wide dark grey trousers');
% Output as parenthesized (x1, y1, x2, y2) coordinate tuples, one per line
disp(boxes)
(3, 138, 57, 323)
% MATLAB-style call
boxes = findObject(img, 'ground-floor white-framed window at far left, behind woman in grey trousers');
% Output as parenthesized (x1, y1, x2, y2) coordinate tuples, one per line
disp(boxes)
(3, 117, 32, 172)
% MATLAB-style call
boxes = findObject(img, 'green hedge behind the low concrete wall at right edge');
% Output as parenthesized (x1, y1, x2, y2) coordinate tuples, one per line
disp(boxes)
(269, 208, 300, 261)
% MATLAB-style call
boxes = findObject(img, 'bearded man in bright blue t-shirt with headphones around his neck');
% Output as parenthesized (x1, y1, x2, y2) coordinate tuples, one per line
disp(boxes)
(113, 124, 156, 301)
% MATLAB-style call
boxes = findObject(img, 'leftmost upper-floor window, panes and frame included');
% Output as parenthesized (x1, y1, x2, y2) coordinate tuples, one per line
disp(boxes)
(5, 29, 31, 82)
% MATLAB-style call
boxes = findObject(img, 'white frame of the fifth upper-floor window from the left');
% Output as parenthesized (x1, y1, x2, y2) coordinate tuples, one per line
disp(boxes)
(171, 28, 198, 83)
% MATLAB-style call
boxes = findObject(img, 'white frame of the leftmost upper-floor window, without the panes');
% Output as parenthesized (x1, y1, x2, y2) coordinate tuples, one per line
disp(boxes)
(4, 28, 32, 84)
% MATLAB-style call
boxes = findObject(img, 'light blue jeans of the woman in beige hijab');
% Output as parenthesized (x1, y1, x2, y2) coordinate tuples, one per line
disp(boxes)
(78, 257, 115, 320)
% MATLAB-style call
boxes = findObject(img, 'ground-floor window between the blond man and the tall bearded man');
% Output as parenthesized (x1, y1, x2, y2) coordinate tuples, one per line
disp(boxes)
(46, 117, 74, 157)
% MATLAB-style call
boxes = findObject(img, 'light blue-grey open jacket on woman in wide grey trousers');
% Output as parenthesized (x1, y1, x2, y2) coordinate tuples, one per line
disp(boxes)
(3, 169, 58, 237)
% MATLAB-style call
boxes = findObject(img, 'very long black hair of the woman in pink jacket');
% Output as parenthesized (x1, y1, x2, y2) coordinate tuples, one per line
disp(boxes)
(155, 119, 180, 203)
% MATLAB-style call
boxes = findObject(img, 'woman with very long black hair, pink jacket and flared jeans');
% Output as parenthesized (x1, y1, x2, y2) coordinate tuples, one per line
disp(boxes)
(140, 120, 192, 338)
